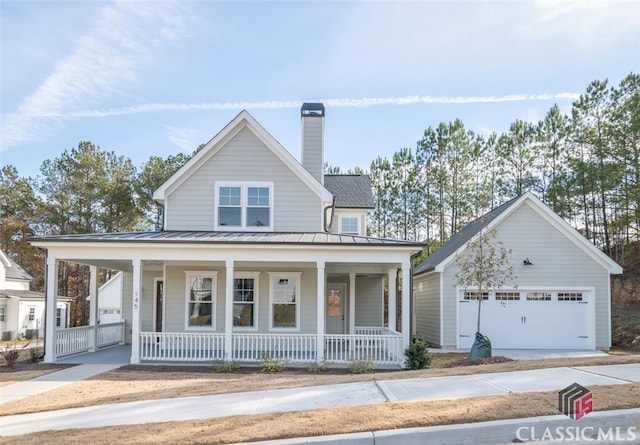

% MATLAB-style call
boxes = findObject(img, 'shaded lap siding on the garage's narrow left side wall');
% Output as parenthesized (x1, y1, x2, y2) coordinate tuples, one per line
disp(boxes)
(414, 272, 442, 346)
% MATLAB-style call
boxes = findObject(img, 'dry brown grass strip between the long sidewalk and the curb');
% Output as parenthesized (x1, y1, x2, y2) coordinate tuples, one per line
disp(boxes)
(0, 383, 640, 445)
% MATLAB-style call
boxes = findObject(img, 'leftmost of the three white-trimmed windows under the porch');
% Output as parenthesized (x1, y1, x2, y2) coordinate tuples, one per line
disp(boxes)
(185, 272, 218, 328)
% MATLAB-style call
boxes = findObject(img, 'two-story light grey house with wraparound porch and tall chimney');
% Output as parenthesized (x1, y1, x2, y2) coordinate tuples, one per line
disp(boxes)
(32, 104, 422, 366)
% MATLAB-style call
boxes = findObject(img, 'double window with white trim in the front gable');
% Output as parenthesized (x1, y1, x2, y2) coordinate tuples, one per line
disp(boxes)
(215, 182, 273, 231)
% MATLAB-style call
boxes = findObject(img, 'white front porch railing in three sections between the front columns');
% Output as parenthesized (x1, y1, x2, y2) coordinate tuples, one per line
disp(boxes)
(140, 327, 403, 366)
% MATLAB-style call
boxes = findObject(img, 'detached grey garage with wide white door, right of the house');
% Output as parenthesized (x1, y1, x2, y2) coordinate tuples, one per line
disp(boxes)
(414, 193, 622, 349)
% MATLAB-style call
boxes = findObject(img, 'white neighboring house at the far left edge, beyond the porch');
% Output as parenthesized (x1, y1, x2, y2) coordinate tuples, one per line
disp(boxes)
(0, 250, 69, 341)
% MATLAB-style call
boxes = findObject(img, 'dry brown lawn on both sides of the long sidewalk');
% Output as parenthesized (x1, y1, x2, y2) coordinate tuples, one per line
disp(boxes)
(0, 354, 640, 445)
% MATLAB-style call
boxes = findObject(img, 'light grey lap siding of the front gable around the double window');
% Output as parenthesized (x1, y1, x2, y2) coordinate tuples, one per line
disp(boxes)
(165, 128, 322, 232)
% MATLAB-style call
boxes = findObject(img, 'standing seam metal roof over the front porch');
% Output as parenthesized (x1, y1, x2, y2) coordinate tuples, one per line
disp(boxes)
(30, 230, 423, 248)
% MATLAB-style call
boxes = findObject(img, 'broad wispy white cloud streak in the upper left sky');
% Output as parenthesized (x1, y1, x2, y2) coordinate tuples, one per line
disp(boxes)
(0, 2, 192, 150)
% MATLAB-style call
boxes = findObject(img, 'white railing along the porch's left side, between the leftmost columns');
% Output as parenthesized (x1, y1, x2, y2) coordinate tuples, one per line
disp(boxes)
(56, 321, 125, 357)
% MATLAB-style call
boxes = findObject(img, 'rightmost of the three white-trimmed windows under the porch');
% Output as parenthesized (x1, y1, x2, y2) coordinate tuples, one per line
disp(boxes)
(269, 272, 302, 330)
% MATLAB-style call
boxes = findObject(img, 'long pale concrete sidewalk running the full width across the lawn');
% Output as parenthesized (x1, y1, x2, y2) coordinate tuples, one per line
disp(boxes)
(0, 363, 640, 436)
